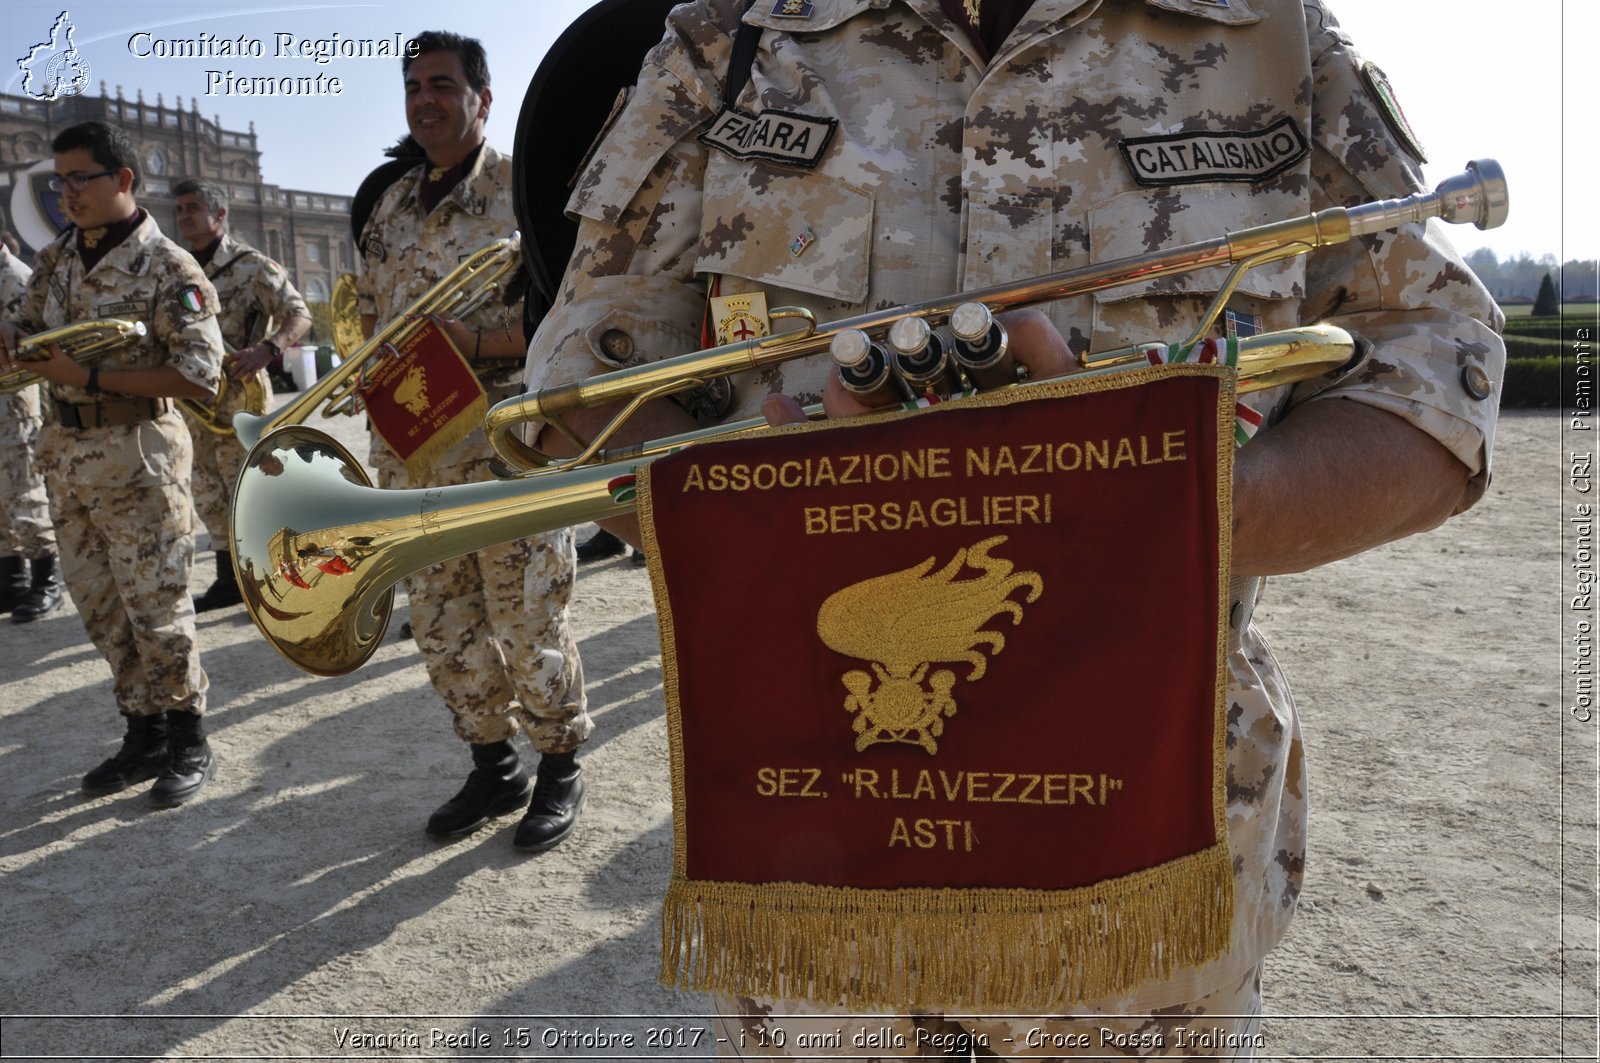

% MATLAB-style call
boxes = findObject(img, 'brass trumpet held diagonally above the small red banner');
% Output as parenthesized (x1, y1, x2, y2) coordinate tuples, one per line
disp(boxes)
(234, 232, 522, 447)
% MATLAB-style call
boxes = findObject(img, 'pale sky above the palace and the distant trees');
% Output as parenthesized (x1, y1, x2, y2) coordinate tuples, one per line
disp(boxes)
(0, 0, 1600, 261)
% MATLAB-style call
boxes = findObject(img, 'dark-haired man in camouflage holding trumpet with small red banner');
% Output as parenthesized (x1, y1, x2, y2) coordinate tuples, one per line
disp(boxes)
(357, 32, 594, 852)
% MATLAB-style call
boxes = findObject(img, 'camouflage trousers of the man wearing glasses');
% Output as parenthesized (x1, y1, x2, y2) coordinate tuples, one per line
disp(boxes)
(50, 480, 210, 716)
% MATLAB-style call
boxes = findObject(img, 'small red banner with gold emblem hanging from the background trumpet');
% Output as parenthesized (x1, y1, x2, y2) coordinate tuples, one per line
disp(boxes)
(360, 319, 488, 479)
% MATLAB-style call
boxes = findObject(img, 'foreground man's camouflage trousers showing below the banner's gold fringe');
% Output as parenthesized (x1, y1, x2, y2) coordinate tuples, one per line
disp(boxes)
(712, 964, 1262, 1060)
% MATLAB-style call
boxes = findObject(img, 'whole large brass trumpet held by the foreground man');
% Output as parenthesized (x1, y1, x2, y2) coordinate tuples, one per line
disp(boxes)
(230, 160, 1506, 676)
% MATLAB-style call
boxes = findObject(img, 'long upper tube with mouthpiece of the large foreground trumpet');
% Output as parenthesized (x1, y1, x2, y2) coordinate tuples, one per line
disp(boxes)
(483, 158, 1507, 471)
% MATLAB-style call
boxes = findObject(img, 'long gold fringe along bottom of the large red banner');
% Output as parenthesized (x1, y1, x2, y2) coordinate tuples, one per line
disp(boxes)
(661, 844, 1234, 1013)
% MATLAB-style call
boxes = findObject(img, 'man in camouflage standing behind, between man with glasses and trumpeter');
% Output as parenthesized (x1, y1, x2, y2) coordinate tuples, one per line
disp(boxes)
(173, 181, 310, 613)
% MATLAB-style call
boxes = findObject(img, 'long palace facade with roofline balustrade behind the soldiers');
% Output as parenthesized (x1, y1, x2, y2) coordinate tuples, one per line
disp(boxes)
(0, 82, 355, 303)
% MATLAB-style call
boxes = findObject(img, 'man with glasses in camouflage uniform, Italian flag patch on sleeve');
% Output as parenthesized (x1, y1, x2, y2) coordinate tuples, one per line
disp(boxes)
(0, 122, 222, 805)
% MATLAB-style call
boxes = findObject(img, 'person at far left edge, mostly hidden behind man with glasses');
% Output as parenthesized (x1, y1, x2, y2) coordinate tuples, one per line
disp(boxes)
(0, 232, 62, 624)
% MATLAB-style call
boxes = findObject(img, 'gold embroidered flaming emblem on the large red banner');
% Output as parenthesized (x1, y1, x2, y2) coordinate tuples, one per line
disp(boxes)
(816, 535, 1045, 754)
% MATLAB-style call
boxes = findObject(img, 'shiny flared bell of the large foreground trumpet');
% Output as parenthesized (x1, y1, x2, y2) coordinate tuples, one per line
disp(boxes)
(229, 424, 393, 676)
